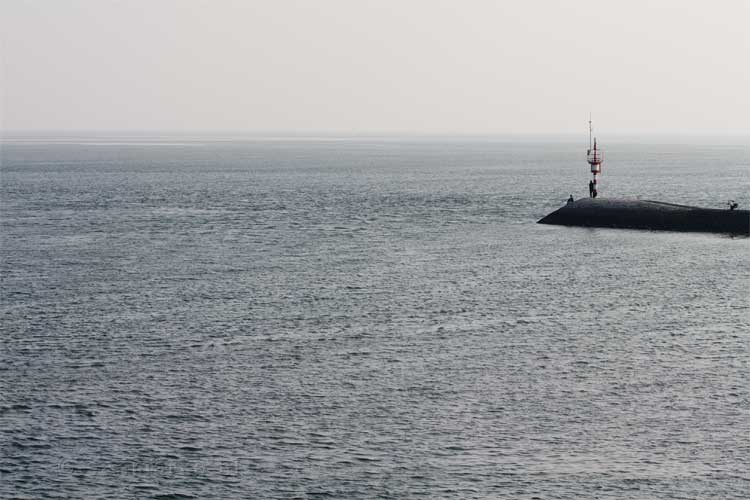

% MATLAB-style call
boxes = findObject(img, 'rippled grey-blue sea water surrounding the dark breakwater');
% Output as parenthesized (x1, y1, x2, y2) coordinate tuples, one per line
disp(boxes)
(0, 138, 750, 499)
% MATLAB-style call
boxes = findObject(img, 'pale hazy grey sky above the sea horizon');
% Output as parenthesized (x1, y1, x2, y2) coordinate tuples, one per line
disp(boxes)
(0, 0, 750, 134)
